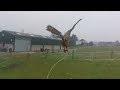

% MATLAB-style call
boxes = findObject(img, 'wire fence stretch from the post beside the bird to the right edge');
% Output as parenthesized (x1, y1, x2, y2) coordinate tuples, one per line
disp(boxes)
(72, 50, 120, 60)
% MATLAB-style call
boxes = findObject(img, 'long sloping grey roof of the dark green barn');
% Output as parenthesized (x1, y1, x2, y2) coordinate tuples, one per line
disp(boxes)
(3, 30, 61, 40)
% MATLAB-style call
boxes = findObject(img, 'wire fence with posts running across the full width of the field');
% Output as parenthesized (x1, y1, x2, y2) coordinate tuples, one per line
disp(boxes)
(0, 49, 120, 69)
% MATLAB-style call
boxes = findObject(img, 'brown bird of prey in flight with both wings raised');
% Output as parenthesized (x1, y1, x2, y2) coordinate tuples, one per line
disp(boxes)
(46, 19, 82, 52)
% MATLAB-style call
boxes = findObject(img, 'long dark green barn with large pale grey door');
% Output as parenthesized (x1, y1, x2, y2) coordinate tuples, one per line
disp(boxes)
(0, 30, 61, 52)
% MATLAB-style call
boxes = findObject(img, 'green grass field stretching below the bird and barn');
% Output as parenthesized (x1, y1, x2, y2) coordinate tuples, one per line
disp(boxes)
(0, 47, 120, 79)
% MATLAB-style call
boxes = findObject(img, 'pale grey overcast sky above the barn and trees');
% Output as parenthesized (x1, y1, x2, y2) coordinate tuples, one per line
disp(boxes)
(0, 11, 120, 41)
